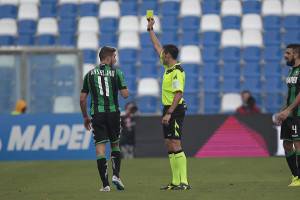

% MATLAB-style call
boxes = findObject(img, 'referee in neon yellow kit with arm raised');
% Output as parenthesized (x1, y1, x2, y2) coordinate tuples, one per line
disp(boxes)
(147, 18, 191, 190)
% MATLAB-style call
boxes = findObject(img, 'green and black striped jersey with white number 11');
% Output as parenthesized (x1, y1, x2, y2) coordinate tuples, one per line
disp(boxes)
(81, 64, 127, 115)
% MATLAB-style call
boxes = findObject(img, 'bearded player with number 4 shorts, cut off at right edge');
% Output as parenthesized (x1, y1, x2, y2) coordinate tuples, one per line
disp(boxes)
(275, 44, 300, 186)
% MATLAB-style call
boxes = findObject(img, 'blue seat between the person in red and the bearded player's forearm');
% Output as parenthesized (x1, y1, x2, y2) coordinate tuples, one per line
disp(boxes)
(265, 92, 285, 113)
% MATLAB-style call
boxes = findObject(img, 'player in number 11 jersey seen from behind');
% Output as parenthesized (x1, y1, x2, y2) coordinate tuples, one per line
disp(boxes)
(80, 46, 128, 192)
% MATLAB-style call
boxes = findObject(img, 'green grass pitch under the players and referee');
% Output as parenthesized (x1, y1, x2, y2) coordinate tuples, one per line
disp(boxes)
(0, 157, 300, 200)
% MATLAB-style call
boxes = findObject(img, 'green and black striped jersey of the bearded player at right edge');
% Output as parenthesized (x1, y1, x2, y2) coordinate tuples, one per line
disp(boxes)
(286, 66, 300, 117)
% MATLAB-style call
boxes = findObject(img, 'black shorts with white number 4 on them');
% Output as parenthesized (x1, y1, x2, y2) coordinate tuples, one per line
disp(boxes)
(280, 117, 300, 141)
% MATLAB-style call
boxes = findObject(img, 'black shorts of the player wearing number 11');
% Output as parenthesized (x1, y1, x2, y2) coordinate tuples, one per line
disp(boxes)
(92, 112, 121, 144)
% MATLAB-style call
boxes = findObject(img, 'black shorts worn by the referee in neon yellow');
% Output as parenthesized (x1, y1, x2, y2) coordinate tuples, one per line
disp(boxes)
(163, 104, 186, 140)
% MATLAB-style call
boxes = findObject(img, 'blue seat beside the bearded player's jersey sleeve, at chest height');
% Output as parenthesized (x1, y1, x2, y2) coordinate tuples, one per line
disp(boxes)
(264, 76, 285, 92)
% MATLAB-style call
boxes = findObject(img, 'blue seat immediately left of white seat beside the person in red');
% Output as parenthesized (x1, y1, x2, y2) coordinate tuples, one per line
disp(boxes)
(204, 92, 221, 114)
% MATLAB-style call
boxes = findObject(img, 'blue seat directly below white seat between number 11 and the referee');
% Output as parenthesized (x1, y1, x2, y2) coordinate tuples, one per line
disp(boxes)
(137, 96, 158, 113)
